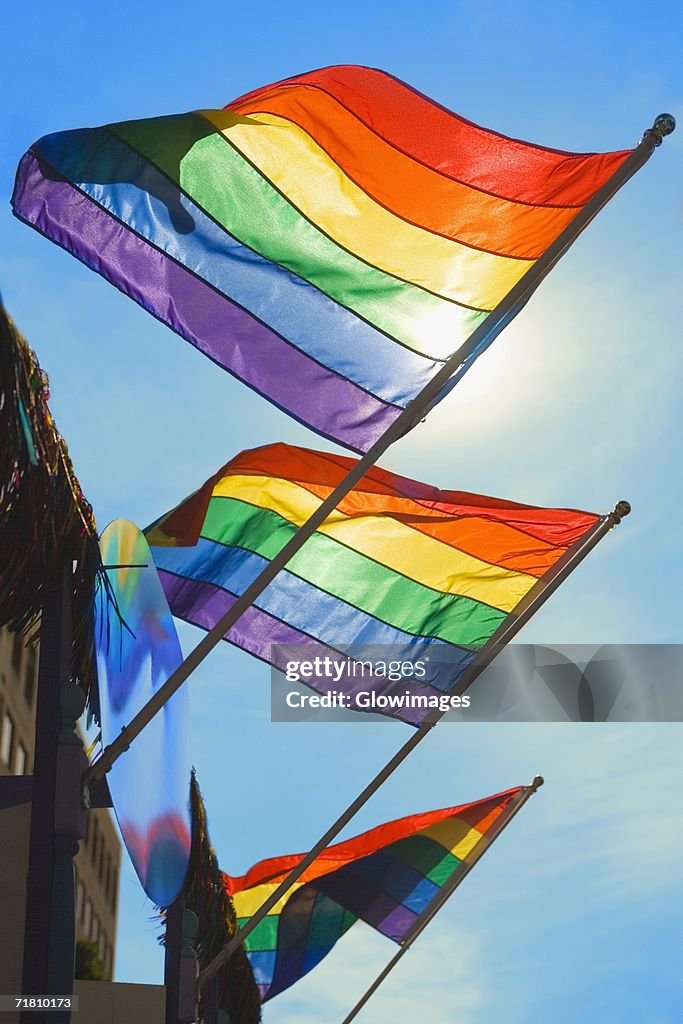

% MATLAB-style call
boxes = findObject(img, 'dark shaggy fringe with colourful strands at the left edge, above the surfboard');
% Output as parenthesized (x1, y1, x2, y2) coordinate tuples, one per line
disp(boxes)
(0, 304, 100, 697)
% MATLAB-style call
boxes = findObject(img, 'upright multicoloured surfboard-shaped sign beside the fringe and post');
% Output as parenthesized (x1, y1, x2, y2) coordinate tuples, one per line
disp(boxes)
(95, 519, 191, 907)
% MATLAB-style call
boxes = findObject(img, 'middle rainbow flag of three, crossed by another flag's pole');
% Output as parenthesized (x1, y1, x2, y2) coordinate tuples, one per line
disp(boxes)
(145, 443, 598, 725)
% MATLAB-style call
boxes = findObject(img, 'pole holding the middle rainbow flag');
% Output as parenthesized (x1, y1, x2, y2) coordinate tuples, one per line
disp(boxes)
(198, 502, 631, 989)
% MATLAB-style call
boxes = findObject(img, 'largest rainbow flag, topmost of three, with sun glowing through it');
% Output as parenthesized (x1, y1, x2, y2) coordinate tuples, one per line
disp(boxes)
(12, 67, 631, 452)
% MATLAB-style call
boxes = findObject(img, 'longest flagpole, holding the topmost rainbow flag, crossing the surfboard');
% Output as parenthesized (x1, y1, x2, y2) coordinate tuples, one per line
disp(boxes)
(83, 114, 676, 804)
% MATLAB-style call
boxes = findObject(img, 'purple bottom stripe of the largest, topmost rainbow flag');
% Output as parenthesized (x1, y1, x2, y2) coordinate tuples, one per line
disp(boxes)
(12, 153, 401, 452)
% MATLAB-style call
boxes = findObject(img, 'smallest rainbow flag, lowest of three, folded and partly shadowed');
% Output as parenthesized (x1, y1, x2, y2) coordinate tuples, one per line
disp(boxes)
(224, 788, 523, 1001)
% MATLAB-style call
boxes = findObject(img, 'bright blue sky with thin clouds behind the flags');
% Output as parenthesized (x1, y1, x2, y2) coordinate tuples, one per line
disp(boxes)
(0, 0, 683, 1024)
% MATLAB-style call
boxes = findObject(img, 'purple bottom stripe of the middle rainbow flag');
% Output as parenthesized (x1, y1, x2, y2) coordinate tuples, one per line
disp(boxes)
(159, 568, 442, 726)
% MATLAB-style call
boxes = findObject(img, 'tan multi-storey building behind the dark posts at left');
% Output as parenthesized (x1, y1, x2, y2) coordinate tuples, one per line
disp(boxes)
(0, 630, 121, 978)
